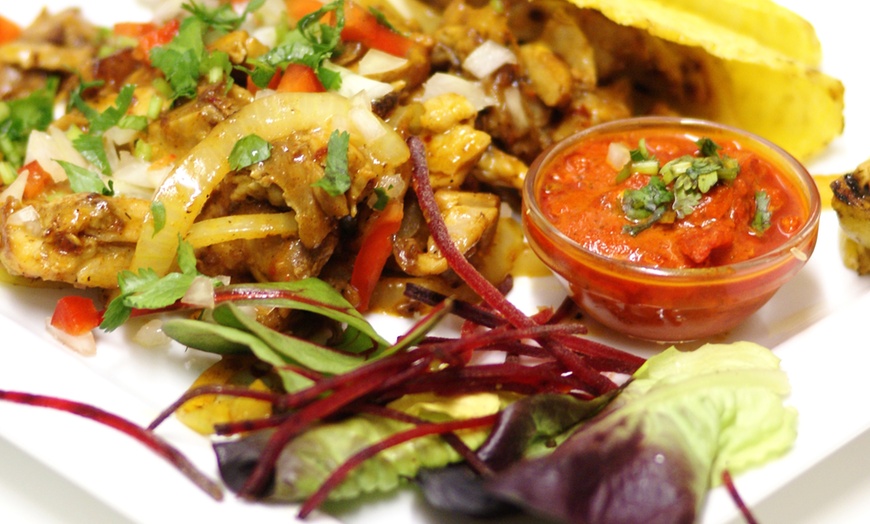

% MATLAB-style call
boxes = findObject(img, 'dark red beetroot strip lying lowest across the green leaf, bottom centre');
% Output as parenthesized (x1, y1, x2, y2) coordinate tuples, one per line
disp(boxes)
(299, 415, 498, 518)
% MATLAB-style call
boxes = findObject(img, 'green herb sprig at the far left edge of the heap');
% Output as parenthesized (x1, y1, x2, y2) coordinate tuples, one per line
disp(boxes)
(0, 77, 59, 170)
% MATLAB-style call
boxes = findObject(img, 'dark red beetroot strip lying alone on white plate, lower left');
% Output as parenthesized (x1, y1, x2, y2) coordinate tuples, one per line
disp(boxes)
(0, 390, 223, 500)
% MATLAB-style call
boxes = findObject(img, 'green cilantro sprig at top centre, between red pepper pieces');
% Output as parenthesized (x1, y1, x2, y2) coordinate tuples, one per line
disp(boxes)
(248, 0, 344, 90)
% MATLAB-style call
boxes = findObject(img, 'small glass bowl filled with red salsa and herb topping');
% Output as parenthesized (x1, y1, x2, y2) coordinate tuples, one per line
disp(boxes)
(523, 117, 821, 342)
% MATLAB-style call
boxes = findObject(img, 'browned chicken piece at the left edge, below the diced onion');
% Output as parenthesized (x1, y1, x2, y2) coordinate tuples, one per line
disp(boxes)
(0, 193, 149, 289)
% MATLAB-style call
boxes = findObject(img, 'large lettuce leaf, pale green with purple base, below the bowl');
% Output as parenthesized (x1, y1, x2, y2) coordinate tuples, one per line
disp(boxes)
(488, 342, 797, 523)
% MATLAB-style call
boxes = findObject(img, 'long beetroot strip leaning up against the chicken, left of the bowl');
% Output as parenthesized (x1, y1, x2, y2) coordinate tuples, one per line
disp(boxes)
(408, 136, 616, 393)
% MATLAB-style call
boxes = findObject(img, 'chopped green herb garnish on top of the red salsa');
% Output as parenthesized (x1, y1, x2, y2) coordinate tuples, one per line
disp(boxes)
(617, 138, 740, 236)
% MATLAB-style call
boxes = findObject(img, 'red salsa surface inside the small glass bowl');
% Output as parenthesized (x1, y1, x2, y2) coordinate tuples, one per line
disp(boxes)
(536, 128, 810, 268)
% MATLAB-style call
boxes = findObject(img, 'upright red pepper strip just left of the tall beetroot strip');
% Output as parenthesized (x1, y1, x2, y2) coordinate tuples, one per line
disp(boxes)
(350, 200, 404, 311)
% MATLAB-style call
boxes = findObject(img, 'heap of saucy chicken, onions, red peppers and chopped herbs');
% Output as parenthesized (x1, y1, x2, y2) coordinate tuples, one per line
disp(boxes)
(0, 0, 839, 308)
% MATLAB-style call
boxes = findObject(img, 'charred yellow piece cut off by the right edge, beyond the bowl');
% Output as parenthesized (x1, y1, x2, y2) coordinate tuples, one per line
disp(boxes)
(831, 160, 870, 275)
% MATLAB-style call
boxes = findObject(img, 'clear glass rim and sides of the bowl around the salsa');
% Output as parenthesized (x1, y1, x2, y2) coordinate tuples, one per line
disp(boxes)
(522, 117, 821, 342)
